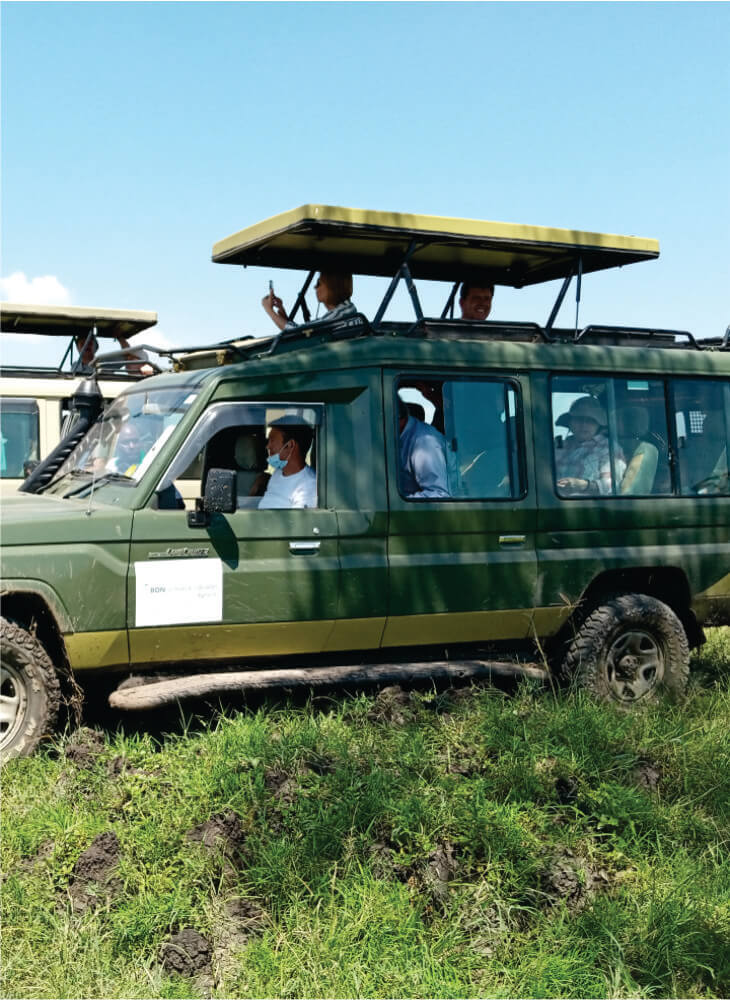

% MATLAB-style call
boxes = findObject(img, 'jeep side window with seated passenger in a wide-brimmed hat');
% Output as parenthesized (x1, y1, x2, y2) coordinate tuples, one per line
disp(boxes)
(551, 375, 672, 497)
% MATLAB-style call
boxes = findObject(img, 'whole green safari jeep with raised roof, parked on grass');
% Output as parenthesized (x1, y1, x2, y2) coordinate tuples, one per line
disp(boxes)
(0, 205, 730, 758)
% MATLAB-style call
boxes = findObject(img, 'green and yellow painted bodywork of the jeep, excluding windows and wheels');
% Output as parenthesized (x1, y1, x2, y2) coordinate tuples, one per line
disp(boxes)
(3, 337, 730, 670)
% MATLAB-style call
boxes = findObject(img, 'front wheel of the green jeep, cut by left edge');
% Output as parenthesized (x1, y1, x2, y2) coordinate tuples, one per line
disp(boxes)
(0, 618, 61, 764)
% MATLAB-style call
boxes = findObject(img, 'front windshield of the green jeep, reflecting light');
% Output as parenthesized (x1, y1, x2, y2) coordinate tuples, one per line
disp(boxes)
(45, 387, 197, 494)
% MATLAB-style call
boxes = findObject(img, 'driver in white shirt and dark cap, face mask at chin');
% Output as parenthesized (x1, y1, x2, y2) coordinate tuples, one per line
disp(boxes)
(259, 416, 317, 510)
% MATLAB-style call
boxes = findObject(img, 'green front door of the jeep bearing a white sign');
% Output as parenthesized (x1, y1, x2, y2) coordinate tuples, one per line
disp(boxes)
(128, 401, 340, 663)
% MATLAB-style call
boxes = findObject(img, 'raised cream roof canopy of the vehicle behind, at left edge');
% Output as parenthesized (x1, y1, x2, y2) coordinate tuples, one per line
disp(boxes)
(0, 302, 157, 338)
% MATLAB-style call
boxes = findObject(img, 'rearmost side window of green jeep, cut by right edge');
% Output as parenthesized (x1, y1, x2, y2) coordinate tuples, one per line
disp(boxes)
(672, 379, 730, 496)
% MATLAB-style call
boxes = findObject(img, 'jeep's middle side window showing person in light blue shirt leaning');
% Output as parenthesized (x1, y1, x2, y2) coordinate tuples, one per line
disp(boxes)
(398, 378, 524, 500)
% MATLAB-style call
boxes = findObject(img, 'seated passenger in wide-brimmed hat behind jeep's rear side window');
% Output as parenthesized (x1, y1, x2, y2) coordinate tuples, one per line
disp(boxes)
(555, 396, 626, 496)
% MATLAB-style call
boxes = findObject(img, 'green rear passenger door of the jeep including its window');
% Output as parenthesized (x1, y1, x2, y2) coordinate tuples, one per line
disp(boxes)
(383, 371, 537, 646)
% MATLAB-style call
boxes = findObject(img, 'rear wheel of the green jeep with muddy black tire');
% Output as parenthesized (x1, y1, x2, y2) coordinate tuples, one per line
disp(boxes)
(563, 594, 689, 707)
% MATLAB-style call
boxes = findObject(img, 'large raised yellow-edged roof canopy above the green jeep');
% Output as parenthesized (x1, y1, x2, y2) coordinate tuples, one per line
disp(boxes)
(213, 205, 659, 288)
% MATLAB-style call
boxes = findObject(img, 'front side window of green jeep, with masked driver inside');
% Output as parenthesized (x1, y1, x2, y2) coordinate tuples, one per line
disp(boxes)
(158, 403, 322, 509)
